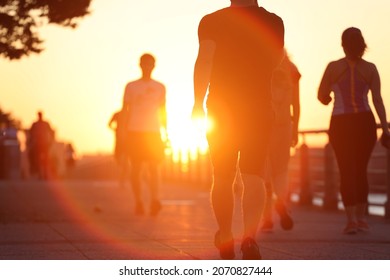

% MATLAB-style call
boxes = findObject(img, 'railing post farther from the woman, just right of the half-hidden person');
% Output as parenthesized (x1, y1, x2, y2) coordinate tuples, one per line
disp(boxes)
(299, 143, 313, 205)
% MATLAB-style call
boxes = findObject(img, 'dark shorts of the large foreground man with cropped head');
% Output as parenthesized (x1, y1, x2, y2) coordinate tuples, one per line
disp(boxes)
(207, 107, 274, 177)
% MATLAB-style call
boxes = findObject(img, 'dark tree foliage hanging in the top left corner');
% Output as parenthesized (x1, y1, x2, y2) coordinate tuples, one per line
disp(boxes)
(0, 0, 92, 59)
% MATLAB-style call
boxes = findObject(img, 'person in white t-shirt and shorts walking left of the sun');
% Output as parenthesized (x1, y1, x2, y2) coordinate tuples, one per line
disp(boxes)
(123, 54, 166, 215)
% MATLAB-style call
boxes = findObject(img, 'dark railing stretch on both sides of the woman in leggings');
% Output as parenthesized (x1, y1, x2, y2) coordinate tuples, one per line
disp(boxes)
(291, 129, 390, 219)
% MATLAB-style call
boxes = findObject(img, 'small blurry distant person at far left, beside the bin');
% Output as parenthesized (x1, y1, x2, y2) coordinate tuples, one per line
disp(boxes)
(29, 111, 54, 179)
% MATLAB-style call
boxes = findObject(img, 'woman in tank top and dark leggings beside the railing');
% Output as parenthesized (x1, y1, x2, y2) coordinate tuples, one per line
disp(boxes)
(318, 27, 389, 234)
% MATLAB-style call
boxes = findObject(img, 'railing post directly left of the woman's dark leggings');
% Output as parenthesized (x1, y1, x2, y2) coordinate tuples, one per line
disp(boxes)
(323, 143, 338, 210)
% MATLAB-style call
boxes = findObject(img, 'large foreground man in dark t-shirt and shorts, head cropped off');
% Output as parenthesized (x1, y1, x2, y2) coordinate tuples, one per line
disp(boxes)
(192, 0, 284, 259)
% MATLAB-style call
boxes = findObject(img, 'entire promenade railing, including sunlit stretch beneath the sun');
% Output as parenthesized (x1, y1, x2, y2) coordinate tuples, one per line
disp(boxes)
(163, 126, 390, 219)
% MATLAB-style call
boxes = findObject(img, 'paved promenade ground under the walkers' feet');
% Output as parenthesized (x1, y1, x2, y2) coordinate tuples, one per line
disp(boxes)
(0, 181, 390, 260)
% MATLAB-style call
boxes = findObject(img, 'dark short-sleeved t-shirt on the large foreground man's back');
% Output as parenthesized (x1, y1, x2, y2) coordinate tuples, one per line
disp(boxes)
(199, 6, 284, 103)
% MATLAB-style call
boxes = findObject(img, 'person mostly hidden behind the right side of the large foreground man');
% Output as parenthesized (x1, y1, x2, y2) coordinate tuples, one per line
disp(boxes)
(262, 50, 301, 231)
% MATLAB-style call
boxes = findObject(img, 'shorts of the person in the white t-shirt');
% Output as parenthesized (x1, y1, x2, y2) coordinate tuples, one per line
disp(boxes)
(127, 132, 164, 162)
